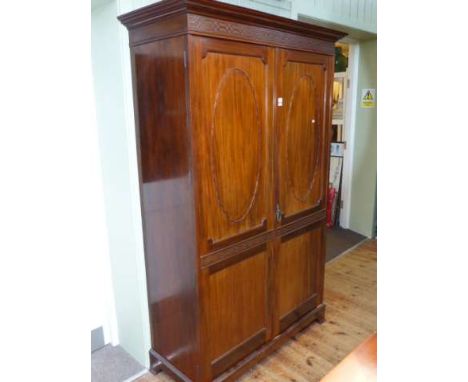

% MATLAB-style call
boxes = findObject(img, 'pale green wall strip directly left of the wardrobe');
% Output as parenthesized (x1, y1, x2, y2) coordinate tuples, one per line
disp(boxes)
(91, 1, 150, 366)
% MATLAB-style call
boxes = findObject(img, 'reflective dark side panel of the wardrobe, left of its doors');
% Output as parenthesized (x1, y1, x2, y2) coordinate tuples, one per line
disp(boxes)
(132, 36, 198, 379)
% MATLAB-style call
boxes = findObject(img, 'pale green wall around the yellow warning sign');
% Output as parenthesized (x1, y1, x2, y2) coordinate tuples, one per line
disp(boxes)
(349, 39, 378, 237)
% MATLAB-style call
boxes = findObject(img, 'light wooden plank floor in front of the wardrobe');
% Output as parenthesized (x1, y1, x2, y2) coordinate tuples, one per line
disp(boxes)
(137, 240, 377, 382)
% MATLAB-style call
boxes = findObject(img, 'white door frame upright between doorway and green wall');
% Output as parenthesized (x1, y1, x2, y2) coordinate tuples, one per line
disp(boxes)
(340, 42, 359, 229)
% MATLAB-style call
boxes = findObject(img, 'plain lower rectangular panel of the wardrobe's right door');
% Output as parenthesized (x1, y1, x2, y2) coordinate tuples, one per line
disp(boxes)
(275, 226, 324, 333)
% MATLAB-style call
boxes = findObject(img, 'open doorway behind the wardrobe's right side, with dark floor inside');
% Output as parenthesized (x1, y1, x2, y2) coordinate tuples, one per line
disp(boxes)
(327, 42, 366, 261)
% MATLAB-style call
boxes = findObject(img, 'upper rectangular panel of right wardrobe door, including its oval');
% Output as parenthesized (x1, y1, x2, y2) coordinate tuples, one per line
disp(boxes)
(277, 49, 328, 223)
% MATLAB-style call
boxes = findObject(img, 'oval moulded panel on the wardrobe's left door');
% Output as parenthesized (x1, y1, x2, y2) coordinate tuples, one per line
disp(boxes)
(210, 68, 262, 222)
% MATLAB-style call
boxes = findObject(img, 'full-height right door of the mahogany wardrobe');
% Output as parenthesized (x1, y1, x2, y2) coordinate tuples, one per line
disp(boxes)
(274, 49, 333, 334)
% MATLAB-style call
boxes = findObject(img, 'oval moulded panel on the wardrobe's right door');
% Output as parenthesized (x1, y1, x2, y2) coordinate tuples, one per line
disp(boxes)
(286, 75, 320, 202)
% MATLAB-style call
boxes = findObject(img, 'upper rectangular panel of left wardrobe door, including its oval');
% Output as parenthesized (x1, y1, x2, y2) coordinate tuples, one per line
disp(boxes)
(190, 37, 272, 251)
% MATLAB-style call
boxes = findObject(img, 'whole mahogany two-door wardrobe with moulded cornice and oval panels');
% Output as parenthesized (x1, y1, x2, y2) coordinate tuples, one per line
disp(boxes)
(119, 0, 344, 382)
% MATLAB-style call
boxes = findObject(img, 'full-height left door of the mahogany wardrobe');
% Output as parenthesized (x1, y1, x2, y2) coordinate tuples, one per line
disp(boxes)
(188, 36, 274, 379)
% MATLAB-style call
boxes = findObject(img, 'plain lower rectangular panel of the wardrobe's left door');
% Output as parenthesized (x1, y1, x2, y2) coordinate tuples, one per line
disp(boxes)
(206, 245, 268, 377)
